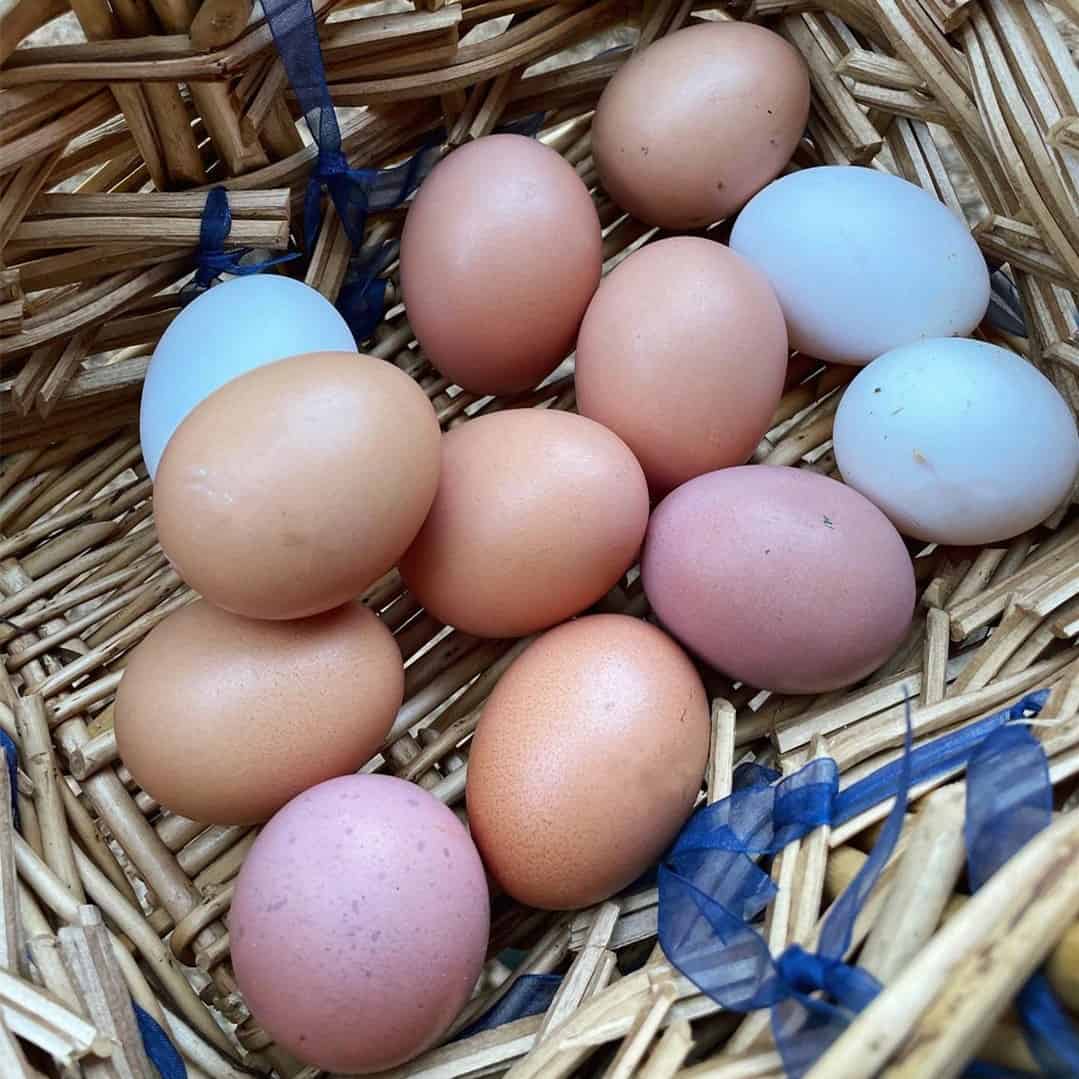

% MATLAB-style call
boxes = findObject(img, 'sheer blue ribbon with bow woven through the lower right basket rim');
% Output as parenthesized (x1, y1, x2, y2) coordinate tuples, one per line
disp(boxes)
(658, 691, 1079, 1077)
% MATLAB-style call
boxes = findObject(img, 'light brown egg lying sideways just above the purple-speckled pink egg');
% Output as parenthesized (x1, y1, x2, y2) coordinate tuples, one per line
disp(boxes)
(114, 601, 405, 824)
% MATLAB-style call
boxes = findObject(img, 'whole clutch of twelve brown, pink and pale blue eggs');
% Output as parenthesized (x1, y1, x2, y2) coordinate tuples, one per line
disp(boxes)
(115, 23, 1079, 1071)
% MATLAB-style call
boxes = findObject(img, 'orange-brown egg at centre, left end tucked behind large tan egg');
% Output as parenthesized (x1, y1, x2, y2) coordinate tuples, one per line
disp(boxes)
(400, 409, 648, 637)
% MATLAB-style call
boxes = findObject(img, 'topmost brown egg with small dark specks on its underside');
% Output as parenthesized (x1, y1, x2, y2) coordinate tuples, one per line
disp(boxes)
(592, 22, 809, 229)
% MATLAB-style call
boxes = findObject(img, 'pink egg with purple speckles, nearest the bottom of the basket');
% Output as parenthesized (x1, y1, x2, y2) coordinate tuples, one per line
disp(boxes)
(236, 775, 490, 1074)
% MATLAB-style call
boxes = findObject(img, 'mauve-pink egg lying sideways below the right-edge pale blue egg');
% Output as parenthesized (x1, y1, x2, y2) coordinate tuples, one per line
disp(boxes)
(641, 465, 915, 693)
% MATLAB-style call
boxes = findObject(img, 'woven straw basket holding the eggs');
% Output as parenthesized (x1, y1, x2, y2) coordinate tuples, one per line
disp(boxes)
(0, 0, 1079, 1079)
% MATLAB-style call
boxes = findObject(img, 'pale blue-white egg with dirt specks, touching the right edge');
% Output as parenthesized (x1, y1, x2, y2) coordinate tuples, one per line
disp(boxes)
(834, 338, 1079, 546)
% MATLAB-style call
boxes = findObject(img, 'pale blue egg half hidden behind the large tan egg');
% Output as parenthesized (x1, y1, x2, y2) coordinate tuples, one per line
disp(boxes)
(139, 274, 356, 479)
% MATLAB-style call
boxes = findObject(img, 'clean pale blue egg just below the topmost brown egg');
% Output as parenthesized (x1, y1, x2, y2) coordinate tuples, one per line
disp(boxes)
(730, 165, 989, 364)
